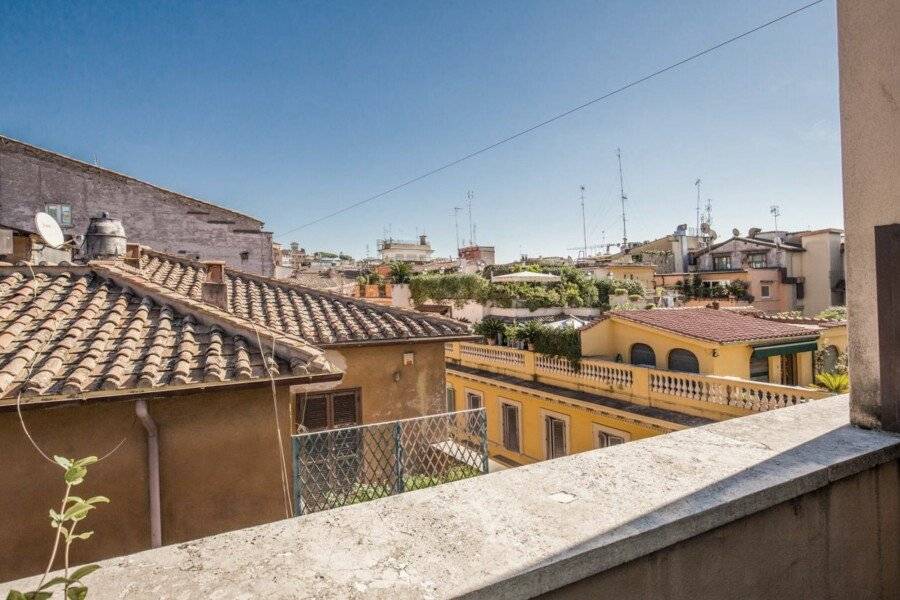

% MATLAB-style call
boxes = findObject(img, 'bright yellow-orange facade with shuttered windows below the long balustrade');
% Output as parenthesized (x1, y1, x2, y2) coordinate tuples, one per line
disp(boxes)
(447, 370, 678, 464)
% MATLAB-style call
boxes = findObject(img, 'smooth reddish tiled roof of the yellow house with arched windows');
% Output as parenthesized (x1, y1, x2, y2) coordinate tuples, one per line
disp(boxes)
(608, 308, 819, 344)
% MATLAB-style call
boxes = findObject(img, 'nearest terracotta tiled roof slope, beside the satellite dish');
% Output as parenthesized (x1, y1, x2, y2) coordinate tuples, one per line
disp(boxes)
(0, 266, 336, 405)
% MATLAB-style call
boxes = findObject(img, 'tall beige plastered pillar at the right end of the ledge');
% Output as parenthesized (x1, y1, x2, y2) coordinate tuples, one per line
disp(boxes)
(837, 0, 900, 431)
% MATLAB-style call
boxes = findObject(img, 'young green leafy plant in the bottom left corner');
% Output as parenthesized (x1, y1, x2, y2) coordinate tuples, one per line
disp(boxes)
(6, 456, 109, 600)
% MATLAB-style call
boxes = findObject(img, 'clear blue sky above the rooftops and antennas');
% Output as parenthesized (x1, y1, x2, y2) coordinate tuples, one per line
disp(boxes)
(0, 0, 842, 260)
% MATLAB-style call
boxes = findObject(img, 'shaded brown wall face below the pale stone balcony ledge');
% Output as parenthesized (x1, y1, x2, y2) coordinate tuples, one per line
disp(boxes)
(540, 460, 900, 600)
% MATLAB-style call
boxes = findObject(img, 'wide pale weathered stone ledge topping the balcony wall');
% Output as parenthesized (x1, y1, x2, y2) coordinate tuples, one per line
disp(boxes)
(0, 396, 900, 599)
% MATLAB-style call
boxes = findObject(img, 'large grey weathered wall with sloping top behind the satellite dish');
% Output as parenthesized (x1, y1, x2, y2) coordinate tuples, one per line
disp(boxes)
(0, 136, 274, 275)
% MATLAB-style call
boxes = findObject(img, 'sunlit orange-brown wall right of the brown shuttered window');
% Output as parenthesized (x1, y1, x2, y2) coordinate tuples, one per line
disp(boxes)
(327, 342, 445, 423)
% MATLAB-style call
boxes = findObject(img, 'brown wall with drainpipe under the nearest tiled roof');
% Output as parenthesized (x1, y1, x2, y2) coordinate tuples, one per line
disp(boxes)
(0, 387, 291, 581)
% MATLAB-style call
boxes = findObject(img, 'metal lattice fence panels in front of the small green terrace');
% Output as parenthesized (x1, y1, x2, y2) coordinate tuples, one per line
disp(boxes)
(291, 408, 488, 515)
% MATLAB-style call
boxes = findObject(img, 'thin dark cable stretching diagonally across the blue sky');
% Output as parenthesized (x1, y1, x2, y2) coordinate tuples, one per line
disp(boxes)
(275, 0, 825, 237)
